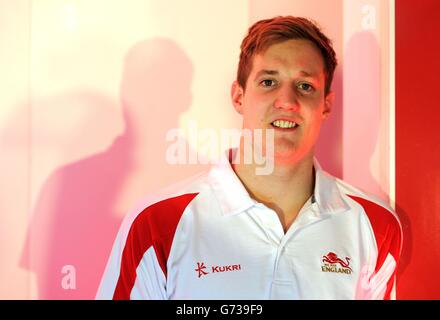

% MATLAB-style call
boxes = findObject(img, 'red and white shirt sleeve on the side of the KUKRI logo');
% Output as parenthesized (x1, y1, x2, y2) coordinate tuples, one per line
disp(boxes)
(97, 193, 198, 300)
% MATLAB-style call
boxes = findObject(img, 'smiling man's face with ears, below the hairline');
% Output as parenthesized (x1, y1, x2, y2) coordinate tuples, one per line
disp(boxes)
(232, 39, 333, 164)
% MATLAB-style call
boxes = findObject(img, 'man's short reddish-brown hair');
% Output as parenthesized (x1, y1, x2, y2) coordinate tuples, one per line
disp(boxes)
(237, 16, 337, 95)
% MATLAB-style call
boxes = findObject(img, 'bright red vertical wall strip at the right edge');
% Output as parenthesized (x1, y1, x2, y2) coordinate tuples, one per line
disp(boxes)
(395, 0, 440, 299)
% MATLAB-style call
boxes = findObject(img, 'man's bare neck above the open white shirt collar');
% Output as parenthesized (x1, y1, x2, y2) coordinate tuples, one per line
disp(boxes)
(232, 150, 315, 232)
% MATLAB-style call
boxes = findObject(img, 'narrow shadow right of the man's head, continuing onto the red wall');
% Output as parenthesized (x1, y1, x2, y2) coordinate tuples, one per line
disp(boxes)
(344, 31, 413, 298)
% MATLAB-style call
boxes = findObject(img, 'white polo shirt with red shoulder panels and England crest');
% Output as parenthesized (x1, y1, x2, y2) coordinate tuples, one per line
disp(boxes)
(97, 150, 402, 300)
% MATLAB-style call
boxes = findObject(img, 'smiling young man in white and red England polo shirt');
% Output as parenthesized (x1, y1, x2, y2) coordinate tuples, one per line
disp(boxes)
(97, 16, 401, 299)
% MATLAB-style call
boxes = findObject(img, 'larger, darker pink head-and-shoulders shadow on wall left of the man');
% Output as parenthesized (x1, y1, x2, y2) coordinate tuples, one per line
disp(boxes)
(20, 38, 205, 299)
